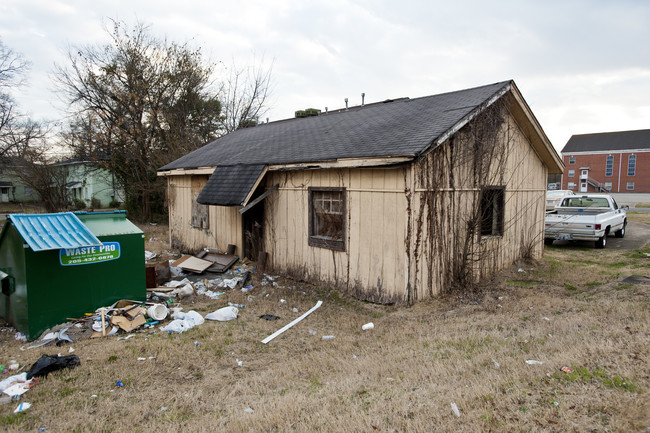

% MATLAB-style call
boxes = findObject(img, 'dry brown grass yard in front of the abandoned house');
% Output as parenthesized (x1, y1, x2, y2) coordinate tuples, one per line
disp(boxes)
(0, 216, 650, 432)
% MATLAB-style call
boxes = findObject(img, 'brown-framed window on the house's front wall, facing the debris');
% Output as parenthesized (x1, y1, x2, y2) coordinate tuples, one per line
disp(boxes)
(309, 188, 345, 251)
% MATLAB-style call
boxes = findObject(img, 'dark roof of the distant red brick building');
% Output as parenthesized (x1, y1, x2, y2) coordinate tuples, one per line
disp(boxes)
(562, 129, 650, 153)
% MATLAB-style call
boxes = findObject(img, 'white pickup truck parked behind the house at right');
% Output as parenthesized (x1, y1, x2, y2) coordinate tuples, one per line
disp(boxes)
(544, 194, 628, 248)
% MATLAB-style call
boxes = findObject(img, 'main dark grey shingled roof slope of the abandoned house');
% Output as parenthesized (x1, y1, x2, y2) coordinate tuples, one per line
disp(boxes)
(159, 81, 511, 170)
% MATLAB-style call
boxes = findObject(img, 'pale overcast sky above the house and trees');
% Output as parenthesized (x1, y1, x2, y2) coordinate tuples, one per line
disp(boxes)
(0, 0, 650, 152)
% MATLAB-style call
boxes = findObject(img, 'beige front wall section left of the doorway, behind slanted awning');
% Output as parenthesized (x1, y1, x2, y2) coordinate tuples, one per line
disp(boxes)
(167, 175, 242, 254)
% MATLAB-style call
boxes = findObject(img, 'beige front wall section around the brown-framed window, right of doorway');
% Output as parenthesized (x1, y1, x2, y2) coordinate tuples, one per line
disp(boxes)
(265, 169, 408, 302)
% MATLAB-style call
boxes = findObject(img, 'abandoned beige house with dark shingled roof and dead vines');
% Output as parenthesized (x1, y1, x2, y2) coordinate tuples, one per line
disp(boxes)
(158, 81, 563, 303)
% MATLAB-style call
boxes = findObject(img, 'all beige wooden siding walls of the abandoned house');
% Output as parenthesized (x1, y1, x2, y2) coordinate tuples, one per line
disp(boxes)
(163, 102, 547, 303)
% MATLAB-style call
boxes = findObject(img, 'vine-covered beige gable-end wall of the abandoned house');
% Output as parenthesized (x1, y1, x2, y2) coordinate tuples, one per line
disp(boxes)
(408, 107, 547, 300)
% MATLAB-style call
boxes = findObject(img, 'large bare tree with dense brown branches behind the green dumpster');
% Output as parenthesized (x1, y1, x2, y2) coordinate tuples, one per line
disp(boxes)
(56, 21, 221, 219)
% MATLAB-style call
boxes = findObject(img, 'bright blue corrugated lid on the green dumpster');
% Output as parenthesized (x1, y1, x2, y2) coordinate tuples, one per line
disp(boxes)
(9, 212, 102, 251)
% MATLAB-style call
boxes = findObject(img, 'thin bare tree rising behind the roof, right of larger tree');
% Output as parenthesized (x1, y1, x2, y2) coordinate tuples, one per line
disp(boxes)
(215, 62, 272, 133)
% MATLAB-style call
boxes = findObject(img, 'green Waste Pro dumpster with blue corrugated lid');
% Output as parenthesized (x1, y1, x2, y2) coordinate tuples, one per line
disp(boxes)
(0, 211, 146, 340)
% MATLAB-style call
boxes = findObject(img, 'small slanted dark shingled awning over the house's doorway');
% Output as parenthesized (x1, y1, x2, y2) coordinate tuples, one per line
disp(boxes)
(196, 164, 264, 206)
